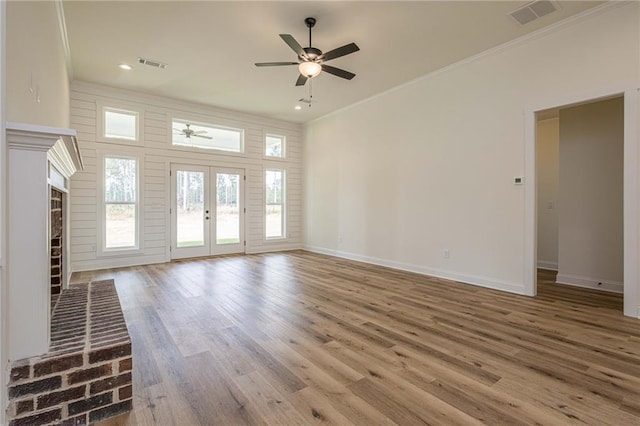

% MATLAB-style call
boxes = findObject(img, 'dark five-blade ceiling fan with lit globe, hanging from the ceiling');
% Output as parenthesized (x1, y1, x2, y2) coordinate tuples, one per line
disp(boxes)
(256, 17, 360, 86)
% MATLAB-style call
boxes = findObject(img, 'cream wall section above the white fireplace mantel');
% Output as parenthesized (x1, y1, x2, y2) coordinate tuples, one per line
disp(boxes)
(6, 1, 69, 128)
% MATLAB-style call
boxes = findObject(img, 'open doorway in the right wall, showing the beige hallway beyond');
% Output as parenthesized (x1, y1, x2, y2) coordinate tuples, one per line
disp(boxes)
(536, 96, 624, 310)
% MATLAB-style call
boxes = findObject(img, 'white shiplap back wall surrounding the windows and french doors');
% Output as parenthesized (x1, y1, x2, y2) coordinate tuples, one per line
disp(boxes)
(71, 82, 302, 271)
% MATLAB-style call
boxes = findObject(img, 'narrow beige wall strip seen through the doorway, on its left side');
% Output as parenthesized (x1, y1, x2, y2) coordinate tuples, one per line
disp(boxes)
(536, 117, 560, 270)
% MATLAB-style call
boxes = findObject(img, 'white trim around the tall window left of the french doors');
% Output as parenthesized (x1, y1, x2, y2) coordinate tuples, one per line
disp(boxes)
(96, 151, 144, 257)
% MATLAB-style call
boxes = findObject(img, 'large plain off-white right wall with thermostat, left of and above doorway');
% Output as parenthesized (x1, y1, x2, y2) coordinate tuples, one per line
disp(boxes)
(304, 3, 640, 300)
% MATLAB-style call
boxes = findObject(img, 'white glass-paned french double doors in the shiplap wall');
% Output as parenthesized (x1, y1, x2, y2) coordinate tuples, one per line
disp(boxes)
(171, 164, 245, 259)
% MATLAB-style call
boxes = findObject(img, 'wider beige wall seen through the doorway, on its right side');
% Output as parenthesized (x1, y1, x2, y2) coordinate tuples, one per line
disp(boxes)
(557, 98, 624, 292)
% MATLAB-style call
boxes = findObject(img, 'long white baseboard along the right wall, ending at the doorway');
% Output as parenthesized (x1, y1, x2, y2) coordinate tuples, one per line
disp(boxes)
(304, 246, 526, 295)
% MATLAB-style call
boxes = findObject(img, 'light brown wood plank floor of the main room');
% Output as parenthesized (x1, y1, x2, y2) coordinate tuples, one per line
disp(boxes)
(73, 251, 640, 425)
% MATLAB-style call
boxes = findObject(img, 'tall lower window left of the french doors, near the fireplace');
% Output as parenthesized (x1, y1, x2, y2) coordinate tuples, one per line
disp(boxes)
(103, 157, 139, 250)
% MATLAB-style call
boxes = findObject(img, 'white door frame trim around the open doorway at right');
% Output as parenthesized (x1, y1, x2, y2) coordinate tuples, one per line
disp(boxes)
(524, 82, 640, 318)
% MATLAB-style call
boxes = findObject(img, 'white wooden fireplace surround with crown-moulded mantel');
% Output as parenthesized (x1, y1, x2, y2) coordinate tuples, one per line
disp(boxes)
(6, 122, 83, 361)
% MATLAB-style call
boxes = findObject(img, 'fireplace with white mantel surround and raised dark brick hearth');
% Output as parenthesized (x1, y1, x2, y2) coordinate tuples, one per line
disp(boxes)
(3, 123, 133, 426)
